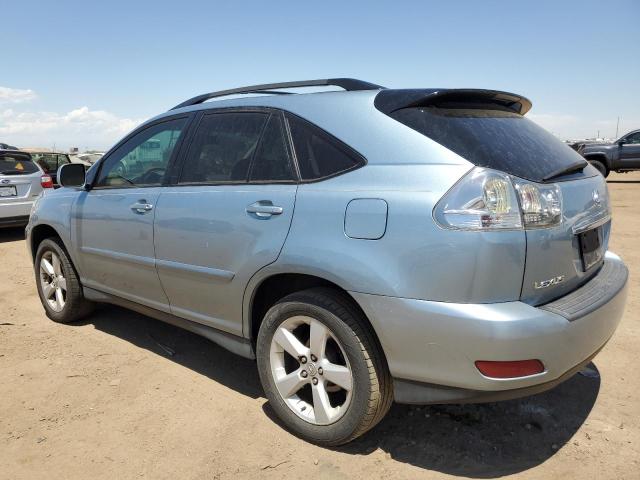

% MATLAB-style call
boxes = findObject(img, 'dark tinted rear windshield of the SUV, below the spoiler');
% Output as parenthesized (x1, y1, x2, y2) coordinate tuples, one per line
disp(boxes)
(389, 107, 584, 182)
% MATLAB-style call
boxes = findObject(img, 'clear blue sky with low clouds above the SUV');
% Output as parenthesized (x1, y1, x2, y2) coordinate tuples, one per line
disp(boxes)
(0, 0, 640, 149)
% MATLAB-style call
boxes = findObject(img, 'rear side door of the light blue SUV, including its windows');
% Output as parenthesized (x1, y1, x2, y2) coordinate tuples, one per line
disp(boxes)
(154, 110, 297, 335)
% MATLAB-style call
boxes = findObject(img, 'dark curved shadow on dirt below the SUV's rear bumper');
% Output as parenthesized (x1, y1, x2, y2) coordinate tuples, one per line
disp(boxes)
(263, 364, 600, 478)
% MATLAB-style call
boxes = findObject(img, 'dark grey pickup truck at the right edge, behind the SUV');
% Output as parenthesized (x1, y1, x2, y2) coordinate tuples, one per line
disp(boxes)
(575, 130, 640, 177)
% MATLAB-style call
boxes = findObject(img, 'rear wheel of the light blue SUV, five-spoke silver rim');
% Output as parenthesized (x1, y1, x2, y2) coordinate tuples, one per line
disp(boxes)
(257, 288, 393, 446)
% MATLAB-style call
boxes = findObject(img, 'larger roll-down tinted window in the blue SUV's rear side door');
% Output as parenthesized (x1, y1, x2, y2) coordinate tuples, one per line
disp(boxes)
(180, 112, 268, 183)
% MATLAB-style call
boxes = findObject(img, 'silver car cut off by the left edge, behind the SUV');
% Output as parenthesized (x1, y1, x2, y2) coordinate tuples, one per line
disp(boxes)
(0, 150, 53, 228)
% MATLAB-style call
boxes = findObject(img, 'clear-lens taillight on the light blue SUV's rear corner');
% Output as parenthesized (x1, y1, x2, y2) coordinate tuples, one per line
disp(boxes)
(433, 167, 562, 231)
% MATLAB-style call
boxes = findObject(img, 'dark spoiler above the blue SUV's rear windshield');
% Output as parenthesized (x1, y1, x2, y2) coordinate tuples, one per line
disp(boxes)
(374, 88, 532, 115)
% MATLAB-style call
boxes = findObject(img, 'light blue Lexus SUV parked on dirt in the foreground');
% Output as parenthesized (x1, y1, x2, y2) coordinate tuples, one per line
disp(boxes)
(27, 78, 628, 445)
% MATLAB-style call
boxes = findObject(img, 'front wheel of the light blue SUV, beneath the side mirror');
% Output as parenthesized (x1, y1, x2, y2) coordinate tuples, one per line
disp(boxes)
(35, 237, 94, 323)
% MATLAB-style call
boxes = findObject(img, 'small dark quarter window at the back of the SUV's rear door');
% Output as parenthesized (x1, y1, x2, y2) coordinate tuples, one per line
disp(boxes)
(251, 115, 294, 182)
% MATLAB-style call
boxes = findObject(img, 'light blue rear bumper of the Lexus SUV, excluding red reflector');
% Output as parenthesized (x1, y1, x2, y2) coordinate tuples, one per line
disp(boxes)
(352, 252, 627, 403)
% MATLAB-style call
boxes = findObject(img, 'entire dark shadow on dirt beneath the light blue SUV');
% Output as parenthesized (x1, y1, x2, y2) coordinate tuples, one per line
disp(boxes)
(76, 306, 600, 478)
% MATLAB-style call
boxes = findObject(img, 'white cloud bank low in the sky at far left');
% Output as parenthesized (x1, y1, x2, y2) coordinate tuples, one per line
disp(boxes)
(0, 87, 141, 149)
